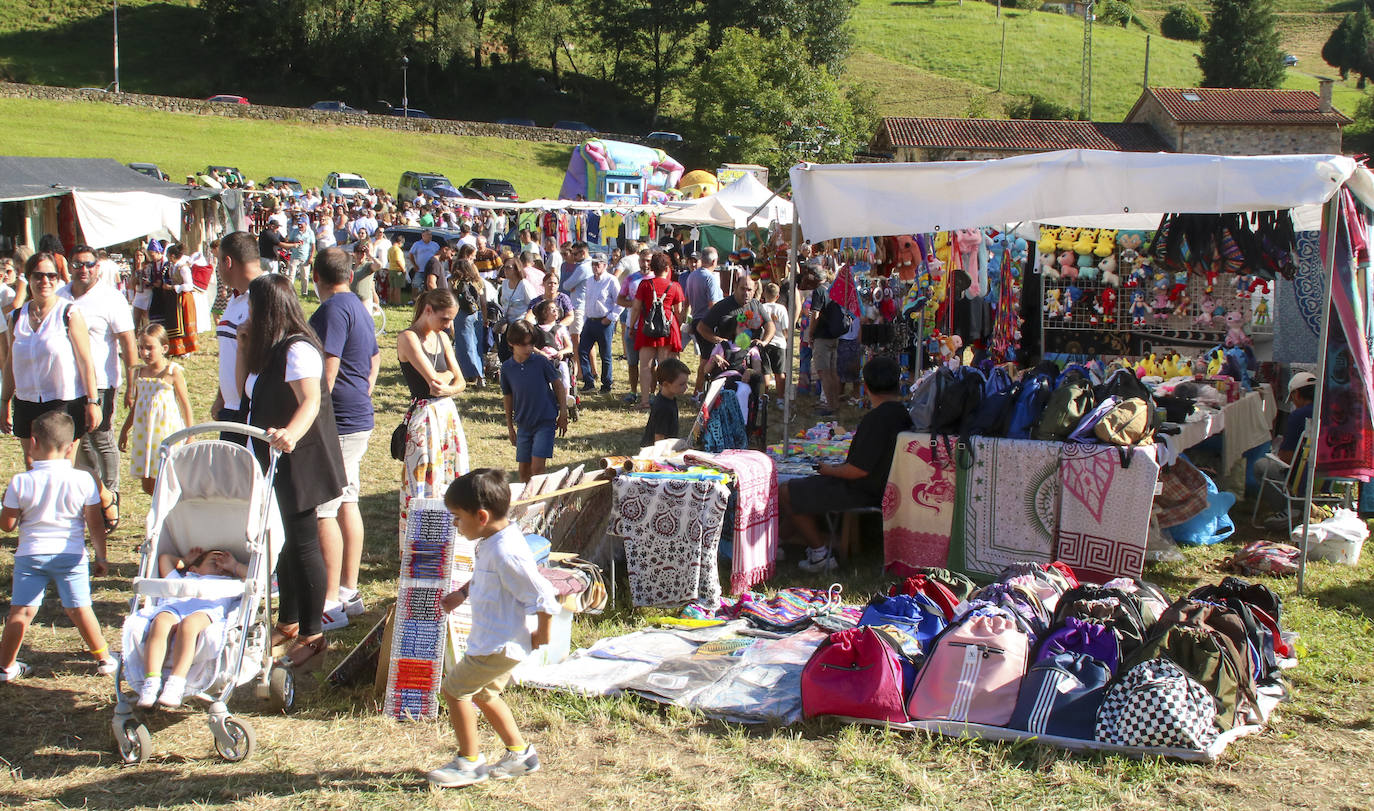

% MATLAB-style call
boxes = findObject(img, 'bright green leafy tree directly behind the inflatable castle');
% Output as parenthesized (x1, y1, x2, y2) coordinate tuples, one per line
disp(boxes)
(683, 29, 877, 172)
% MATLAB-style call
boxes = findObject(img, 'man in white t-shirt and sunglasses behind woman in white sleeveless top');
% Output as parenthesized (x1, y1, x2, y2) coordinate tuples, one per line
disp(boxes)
(58, 245, 133, 492)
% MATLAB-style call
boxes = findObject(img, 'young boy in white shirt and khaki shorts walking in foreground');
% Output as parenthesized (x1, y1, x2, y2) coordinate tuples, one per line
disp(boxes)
(427, 467, 558, 789)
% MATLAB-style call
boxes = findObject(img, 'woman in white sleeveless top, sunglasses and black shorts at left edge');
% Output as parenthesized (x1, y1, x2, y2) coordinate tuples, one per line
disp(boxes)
(0, 252, 120, 531)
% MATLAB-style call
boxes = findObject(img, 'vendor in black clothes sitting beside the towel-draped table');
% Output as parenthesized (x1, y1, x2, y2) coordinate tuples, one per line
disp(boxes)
(778, 357, 911, 572)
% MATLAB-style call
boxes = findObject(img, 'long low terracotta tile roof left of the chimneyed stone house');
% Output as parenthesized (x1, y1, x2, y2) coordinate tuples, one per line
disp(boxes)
(879, 118, 1169, 153)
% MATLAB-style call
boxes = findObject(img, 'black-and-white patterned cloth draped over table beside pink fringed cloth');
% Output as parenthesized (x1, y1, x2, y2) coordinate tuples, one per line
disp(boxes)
(607, 476, 730, 606)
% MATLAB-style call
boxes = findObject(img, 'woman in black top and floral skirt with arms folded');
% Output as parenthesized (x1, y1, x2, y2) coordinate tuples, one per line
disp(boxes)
(396, 287, 467, 539)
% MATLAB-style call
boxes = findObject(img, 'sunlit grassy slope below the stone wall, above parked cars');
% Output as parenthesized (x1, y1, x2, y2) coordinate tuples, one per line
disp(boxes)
(0, 99, 569, 199)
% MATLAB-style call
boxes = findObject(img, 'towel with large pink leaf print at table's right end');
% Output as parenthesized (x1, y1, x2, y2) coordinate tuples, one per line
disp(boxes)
(1055, 443, 1160, 583)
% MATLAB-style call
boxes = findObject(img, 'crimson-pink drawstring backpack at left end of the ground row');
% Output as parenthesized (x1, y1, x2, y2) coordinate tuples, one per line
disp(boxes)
(801, 625, 912, 723)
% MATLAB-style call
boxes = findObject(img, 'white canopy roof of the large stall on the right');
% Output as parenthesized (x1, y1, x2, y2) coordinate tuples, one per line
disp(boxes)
(791, 150, 1374, 241)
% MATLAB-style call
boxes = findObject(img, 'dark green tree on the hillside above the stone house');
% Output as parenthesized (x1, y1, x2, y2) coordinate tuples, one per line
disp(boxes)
(1198, 0, 1283, 88)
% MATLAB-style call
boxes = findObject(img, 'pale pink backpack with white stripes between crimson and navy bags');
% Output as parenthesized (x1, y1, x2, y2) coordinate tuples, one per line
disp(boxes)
(907, 614, 1031, 727)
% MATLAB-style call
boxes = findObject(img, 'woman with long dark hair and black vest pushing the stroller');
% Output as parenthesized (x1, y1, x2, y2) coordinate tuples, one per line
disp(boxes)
(238, 274, 346, 668)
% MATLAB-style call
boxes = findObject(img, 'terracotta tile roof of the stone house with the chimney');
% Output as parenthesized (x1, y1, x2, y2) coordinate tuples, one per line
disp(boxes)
(1125, 88, 1351, 125)
